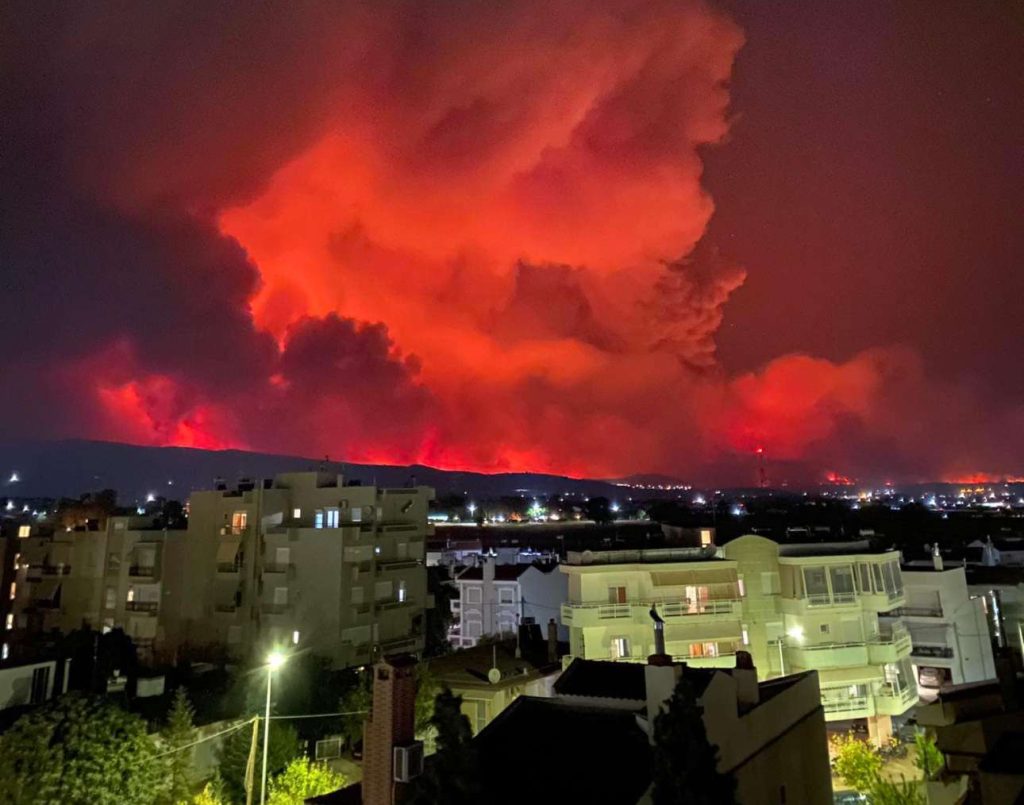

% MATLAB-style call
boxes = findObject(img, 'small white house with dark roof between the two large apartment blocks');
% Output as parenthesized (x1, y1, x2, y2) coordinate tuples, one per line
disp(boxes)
(451, 556, 568, 648)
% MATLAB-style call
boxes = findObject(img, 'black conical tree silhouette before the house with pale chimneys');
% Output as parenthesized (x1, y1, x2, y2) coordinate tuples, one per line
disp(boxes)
(652, 678, 736, 805)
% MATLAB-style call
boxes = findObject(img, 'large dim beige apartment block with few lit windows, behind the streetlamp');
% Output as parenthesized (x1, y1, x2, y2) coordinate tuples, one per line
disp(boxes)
(176, 472, 433, 667)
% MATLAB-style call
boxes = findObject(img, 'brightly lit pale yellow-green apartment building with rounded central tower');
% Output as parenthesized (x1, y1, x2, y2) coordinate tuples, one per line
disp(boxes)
(561, 536, 918, 736)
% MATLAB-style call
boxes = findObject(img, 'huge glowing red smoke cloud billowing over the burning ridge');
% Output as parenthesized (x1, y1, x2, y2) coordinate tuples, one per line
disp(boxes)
(6, 0, 1016, 480)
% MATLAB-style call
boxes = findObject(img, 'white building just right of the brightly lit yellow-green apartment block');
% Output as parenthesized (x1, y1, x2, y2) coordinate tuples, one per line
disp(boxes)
(900, 559, 995, 698)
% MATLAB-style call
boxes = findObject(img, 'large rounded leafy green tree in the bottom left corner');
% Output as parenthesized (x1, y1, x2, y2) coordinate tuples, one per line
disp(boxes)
(0, 693, 162, 805)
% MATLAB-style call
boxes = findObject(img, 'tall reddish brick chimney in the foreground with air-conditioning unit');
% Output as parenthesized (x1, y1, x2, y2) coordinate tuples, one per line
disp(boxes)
(362, 654, 416, 805)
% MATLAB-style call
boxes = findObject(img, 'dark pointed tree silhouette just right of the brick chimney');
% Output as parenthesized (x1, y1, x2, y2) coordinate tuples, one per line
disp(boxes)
(412, 688, 485, 805)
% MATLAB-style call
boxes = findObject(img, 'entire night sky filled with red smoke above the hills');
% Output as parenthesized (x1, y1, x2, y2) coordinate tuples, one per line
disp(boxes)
(0, 0, 1024, 483)
